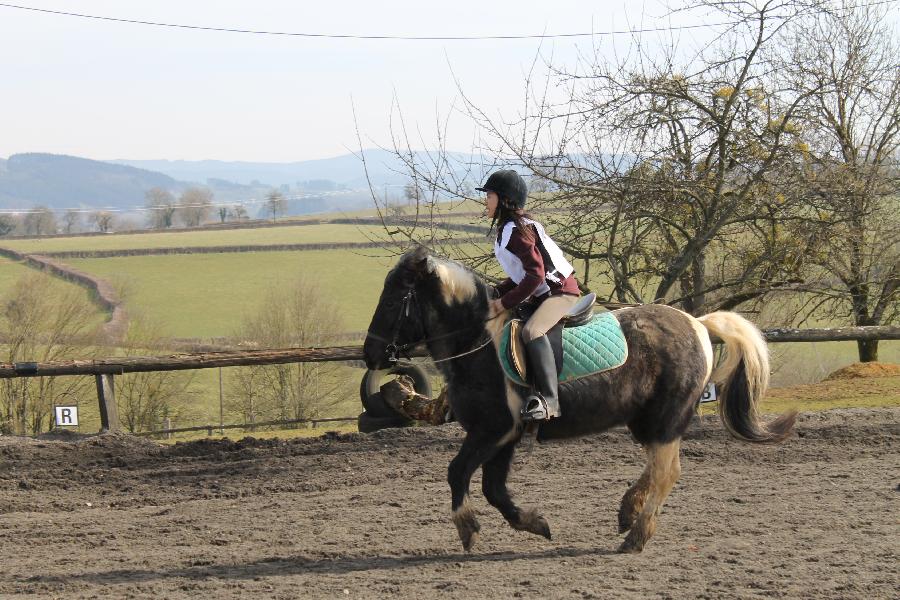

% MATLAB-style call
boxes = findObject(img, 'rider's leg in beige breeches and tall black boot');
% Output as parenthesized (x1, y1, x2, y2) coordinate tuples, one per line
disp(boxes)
(522, 295, 578, 421)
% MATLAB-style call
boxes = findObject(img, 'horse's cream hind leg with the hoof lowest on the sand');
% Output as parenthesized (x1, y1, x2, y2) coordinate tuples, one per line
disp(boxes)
(619, 439, 681, 552)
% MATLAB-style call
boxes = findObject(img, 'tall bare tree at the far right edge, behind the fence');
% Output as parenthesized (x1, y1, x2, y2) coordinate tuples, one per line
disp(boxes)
(779, 3, 900, 362)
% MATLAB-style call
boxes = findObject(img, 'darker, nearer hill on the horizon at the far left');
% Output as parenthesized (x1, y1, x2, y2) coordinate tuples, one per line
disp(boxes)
(0, 153, 184, 208)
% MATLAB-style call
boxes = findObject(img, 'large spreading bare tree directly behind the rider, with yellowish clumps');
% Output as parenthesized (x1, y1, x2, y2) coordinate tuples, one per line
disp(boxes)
(376, 0, 828, 314)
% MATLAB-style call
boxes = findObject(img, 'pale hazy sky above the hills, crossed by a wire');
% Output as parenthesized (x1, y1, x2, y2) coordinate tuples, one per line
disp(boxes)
(0, 0, 724, 161)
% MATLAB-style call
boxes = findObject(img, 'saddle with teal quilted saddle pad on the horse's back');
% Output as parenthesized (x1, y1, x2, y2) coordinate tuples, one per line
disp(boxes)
(499, 294, 628, 386)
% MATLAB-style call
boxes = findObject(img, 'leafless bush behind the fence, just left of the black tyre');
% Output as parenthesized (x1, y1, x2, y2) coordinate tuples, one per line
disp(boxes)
(229, 280, 349, 420)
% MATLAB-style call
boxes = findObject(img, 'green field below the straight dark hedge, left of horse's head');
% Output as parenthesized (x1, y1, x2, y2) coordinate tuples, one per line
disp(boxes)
(67, 250, 396, 338)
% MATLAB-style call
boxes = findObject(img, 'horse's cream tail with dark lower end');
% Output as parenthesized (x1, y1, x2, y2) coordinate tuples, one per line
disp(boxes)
(700, 311, 797, 442)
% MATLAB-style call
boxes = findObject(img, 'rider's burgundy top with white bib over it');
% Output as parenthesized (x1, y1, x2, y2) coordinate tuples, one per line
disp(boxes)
(494, 219, 581, 308)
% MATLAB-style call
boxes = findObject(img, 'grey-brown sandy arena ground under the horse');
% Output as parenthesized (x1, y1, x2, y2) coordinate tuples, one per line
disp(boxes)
(0, 409, 900, 600)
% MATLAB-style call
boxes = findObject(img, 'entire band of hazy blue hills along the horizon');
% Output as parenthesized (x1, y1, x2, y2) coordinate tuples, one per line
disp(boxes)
(0, 150, 492, 216)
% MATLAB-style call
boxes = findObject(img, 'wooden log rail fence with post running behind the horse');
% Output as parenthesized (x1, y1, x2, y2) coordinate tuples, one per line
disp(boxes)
(0, 325, 900, 431)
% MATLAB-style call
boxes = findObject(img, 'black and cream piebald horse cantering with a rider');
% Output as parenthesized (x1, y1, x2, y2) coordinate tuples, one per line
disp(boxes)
(363, 247, 796, 553)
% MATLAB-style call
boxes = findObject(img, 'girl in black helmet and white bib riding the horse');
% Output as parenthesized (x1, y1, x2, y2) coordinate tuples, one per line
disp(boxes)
(475, 170, 581, 421)
